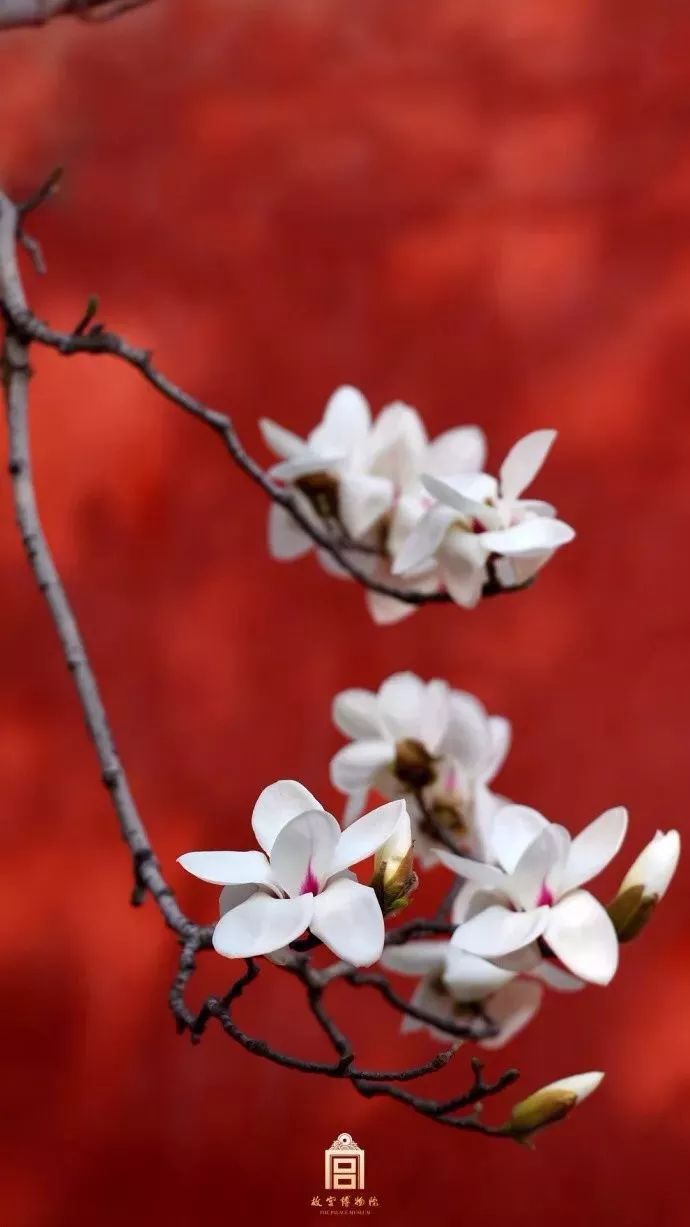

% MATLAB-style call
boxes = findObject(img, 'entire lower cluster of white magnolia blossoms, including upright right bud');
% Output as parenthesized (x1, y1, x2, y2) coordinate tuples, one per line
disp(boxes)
(180, 674, 680, 1047)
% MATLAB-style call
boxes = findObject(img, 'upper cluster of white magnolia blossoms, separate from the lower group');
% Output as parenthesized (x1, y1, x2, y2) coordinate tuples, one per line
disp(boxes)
(260, 387, 575, 623)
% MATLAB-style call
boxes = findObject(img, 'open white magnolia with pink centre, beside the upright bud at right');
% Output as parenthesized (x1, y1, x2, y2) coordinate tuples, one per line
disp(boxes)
(436, 805, 627, 984)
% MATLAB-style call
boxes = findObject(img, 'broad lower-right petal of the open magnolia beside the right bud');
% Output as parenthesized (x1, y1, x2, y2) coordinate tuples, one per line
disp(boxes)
(544, 891, 619, 984)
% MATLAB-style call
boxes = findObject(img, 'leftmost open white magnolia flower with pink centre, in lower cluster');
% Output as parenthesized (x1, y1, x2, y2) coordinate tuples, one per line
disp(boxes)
(179, 779, 405, 967)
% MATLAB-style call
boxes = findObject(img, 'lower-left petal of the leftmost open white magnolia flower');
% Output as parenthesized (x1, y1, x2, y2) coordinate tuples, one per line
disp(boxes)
(214, 891, 314, 958)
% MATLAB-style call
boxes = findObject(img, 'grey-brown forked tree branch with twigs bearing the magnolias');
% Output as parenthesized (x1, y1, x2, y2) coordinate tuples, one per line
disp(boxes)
(0, 181, 516, 1135)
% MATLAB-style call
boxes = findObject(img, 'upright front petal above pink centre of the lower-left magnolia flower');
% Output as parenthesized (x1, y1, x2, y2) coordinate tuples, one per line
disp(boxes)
(270, 810, 340, 896)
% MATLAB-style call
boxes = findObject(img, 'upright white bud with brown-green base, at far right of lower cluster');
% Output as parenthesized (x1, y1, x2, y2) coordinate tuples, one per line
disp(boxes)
(607, 831, 680, 941)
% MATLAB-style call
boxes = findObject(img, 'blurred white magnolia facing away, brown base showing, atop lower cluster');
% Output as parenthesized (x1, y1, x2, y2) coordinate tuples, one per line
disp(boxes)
(330, 672, 511, 860)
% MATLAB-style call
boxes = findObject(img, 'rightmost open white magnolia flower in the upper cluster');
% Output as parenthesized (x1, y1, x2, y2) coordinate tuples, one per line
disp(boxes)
(393, 431, 575, 609)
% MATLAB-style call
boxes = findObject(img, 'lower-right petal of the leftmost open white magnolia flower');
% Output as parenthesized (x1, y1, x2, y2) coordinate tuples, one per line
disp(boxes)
(311, 883, 386, 967)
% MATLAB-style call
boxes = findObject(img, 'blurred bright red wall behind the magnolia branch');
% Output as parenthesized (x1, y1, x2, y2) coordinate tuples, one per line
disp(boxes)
(0, 0, 690, 1227)
